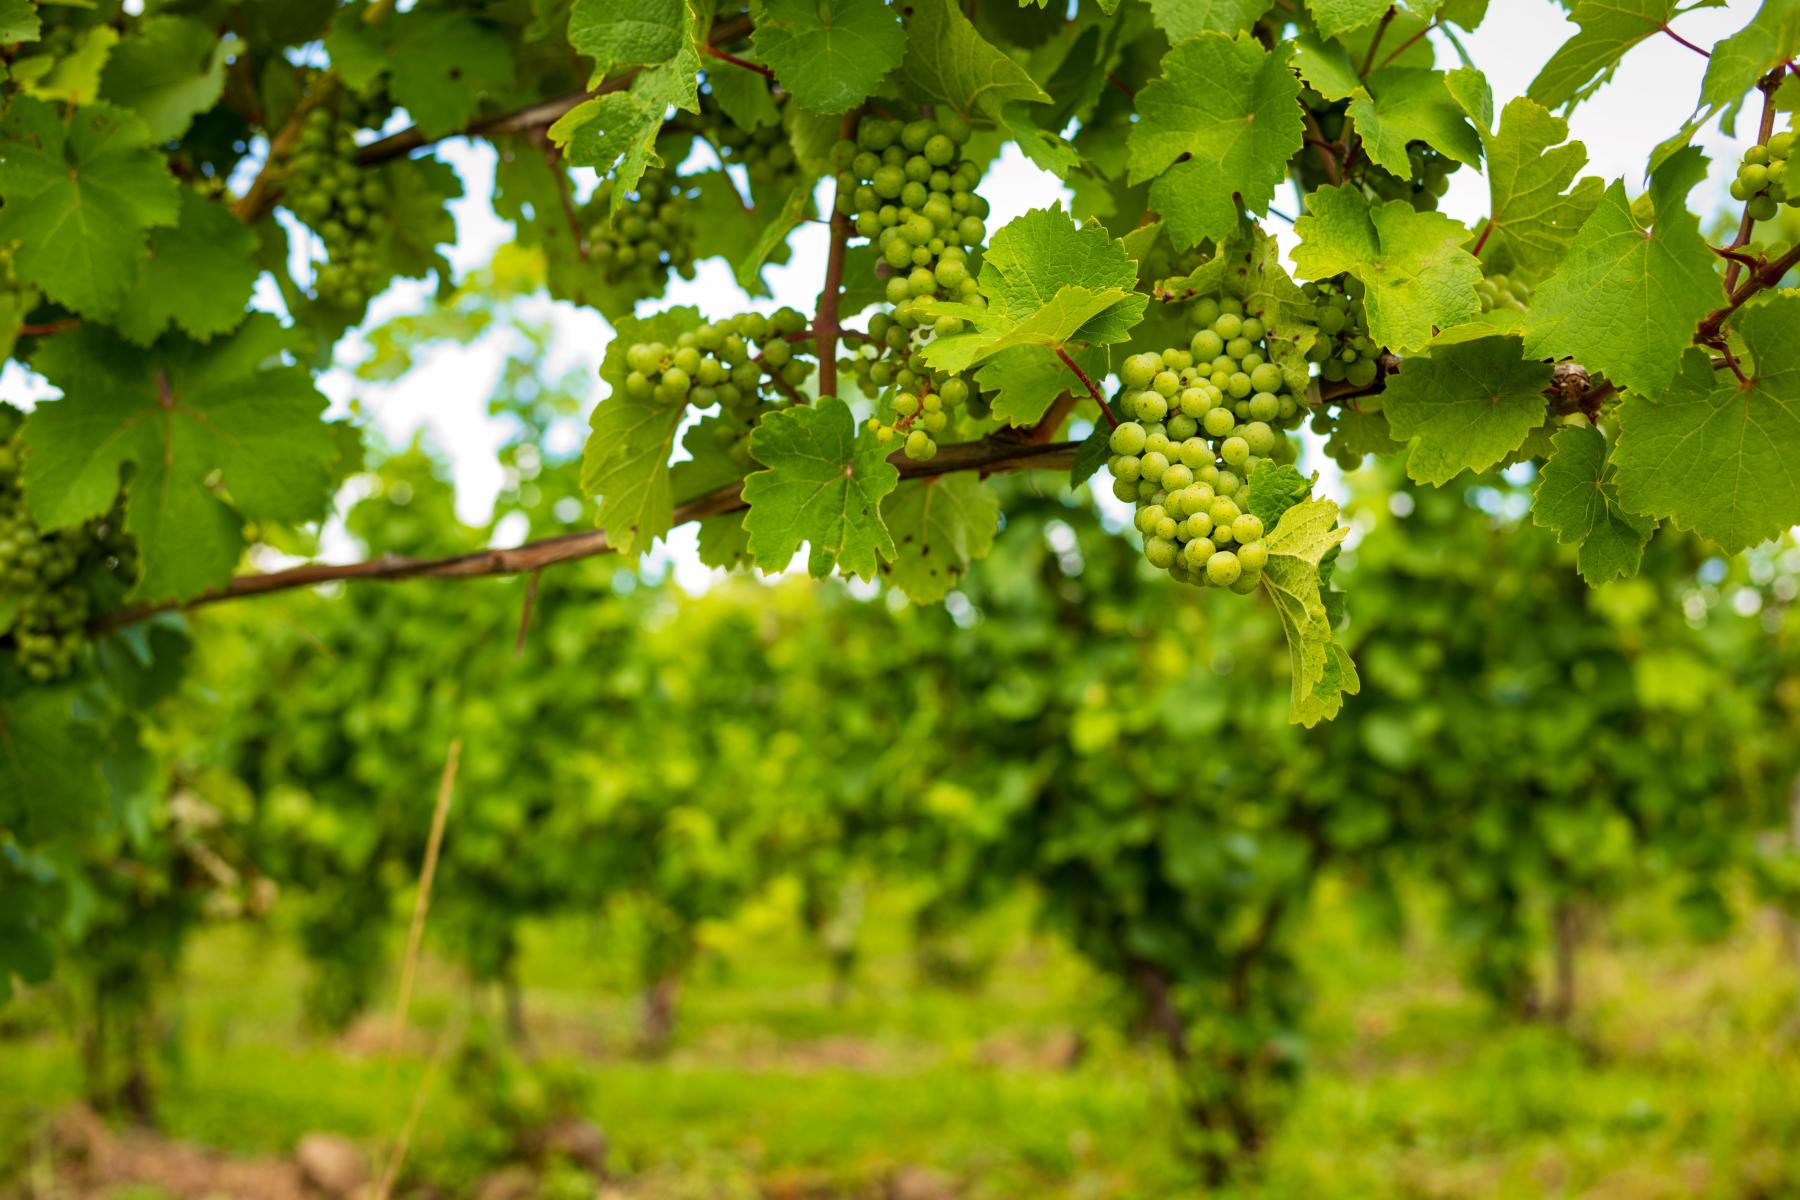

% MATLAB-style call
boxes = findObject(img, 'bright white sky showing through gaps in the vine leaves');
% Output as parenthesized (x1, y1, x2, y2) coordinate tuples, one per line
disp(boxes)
(0, 0, 1757, 590)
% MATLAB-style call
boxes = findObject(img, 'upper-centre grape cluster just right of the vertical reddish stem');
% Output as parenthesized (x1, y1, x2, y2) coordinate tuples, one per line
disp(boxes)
(832, 110, 988, 309)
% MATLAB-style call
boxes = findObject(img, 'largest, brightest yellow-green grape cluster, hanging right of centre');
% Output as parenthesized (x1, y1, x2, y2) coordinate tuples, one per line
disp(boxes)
(1107, 297, 1303, 592)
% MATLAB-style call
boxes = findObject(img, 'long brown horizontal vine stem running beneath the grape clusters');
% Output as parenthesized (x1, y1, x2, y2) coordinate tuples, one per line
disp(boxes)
(92, 437, 1080, 635)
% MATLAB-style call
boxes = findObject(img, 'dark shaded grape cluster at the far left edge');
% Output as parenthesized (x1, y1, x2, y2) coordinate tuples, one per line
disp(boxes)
(0, 437, 137, 684)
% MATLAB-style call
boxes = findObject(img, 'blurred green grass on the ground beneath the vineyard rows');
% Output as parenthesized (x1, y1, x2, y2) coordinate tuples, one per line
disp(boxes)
(0, 877, 1800, 1200)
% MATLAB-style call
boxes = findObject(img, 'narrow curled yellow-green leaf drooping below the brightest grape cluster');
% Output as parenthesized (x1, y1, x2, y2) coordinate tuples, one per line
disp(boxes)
(1262, 500, 1363, 729)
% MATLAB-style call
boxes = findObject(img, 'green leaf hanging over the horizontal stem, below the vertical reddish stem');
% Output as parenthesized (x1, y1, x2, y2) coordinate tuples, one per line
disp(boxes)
(743, 396, 900, 579)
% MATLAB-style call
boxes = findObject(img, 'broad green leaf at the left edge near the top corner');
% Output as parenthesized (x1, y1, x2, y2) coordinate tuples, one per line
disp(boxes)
(0, 97, 180, 318)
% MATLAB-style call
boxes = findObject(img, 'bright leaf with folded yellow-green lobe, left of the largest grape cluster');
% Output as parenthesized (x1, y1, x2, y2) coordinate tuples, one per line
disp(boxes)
(925, 207, 1150, 419)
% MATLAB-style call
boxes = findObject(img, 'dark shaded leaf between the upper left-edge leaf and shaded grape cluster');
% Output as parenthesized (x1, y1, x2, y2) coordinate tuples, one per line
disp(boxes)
(113, 189, 257, 345)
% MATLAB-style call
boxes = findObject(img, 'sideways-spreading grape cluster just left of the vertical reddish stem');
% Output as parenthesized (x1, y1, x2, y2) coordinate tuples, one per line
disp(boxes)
(625, 308, 812, 466)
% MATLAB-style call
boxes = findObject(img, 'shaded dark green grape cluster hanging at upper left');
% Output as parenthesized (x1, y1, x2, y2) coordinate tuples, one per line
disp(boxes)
(286, 97, 387, 308)
